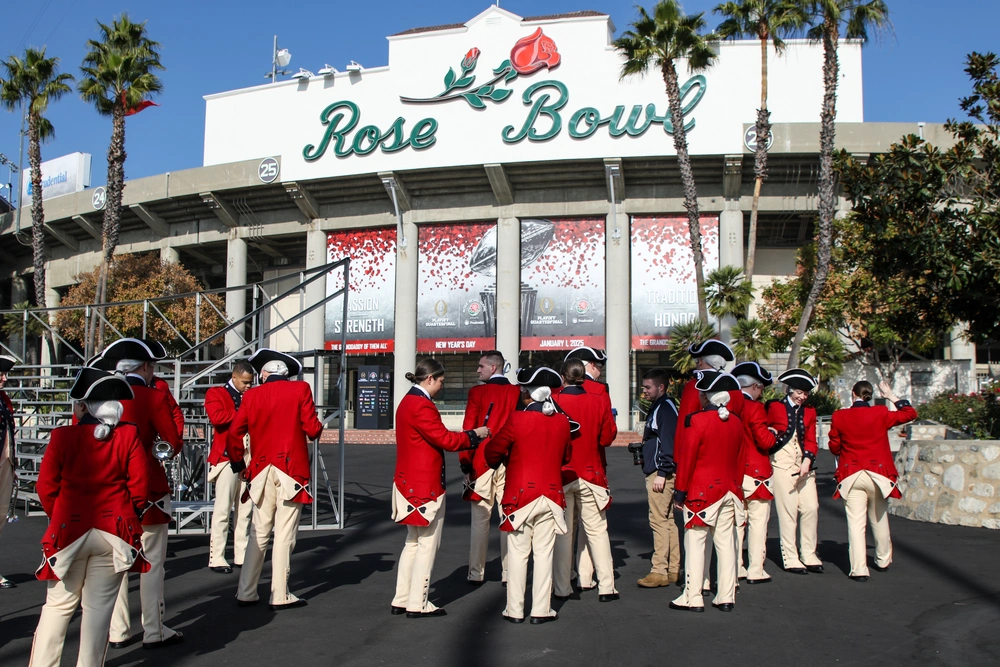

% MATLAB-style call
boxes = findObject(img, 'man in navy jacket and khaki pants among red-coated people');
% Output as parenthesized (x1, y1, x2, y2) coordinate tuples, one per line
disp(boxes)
(637, 368, 681, 588)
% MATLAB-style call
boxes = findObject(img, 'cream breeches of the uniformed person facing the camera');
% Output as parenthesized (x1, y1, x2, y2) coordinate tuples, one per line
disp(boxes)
(771, 468, 822, 569)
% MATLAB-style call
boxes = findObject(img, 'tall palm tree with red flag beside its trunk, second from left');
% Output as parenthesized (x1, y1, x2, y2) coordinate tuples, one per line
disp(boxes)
(79, 13, 165, 356)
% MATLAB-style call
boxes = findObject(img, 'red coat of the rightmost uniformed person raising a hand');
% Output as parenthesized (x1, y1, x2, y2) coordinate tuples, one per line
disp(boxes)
(830, 401, 917, 498)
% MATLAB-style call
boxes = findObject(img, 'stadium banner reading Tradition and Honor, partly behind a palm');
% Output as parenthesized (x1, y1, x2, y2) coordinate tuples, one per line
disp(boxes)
(632, 215, 719, 351)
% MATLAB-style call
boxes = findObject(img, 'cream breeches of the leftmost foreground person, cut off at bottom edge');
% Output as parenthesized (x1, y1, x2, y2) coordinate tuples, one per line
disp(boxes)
(28, 530, 125, 667)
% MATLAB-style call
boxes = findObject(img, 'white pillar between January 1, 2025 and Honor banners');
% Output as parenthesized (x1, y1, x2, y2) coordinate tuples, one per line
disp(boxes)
(604, 204, 632, 430)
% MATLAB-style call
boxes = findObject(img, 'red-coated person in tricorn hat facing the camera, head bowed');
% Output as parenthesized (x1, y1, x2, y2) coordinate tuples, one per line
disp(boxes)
(767, 368, 823, 574)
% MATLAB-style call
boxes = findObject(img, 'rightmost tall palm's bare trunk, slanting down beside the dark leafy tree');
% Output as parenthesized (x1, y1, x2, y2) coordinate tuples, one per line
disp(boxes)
(788, 16, 840, 368)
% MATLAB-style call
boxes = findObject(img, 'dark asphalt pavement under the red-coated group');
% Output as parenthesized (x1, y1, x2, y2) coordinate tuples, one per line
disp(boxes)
(0, 445, 1000, 667)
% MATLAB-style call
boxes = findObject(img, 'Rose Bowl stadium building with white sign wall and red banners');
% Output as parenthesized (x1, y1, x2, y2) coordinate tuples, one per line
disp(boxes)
(0, 7, 975, 427)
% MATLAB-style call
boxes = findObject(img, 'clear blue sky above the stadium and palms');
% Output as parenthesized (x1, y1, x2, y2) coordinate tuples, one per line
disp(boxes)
(0, 0, 1000, 196)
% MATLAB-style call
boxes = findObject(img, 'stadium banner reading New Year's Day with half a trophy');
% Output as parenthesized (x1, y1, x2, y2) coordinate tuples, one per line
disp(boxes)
(417, 222, 497, 352)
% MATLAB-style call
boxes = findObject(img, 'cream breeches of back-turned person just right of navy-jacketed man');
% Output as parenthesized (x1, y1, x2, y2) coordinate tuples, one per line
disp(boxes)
(674, 496, 736, 607)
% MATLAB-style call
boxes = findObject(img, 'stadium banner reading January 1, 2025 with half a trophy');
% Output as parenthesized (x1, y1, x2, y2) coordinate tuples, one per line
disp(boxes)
(521, 218, 605, 350)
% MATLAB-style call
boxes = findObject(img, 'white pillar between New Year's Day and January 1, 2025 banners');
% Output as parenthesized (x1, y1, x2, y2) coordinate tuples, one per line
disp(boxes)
(496, 207, 521, 370)
